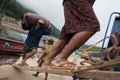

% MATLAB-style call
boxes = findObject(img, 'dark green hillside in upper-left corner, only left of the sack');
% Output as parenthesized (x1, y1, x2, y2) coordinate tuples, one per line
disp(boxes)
(0, 0, 30, 20)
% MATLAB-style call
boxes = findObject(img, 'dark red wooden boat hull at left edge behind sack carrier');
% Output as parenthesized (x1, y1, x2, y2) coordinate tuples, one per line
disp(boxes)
(0, 38, 24, 54)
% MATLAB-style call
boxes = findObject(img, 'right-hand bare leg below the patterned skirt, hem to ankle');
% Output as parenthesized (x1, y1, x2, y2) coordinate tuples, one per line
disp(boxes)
(59, 31, 95, 59)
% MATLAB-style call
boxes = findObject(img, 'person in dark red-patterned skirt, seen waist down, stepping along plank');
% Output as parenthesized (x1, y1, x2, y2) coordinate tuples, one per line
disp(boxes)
(42, 0, 100, 68)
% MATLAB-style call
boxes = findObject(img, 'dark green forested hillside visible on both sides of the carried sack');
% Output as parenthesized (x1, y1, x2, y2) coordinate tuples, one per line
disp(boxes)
(0, 0, 60, 38)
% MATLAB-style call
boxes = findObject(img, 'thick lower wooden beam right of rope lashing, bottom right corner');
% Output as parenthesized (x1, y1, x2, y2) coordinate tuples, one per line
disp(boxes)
(78, 71, 120, 80)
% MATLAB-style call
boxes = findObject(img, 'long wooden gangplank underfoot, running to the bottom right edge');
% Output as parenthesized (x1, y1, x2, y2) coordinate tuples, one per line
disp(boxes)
(13, 65, 120, 80)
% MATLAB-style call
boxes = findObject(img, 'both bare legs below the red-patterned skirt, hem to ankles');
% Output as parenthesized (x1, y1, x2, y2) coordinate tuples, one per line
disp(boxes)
(43, 31, 95, 66)
